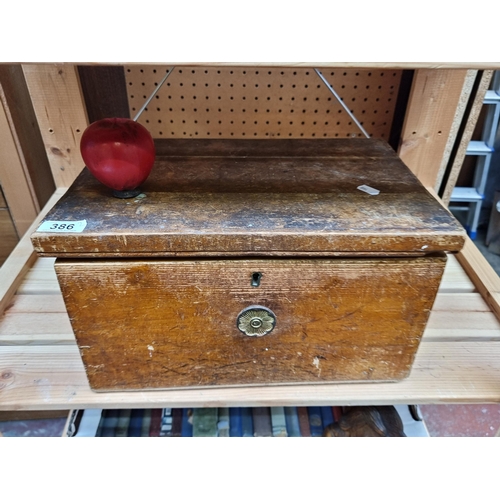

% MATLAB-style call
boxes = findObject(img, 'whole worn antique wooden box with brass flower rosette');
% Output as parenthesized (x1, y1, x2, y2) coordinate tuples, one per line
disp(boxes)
(32, 139, 464, 391)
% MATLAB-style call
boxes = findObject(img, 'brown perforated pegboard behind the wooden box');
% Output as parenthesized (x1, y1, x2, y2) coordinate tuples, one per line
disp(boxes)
(124, 65, 402, 140)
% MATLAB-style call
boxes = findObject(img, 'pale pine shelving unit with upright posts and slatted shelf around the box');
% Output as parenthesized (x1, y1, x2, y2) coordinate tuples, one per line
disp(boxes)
(0, 64, 500, 410)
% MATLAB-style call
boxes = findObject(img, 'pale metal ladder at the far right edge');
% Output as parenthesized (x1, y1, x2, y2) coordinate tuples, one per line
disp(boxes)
(449, 71, 500, 240)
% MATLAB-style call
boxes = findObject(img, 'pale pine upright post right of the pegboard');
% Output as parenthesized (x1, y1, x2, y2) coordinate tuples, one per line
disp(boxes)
(399, 70, 476, 189)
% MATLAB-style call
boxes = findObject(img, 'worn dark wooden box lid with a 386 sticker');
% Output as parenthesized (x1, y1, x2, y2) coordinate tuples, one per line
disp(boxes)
(32, 139, 465, 258)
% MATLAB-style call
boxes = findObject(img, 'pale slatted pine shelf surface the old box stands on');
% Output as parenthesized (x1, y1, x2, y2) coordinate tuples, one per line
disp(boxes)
(0, 256, 500, 410)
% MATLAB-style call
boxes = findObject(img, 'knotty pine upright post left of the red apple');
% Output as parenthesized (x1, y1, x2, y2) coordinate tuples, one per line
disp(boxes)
(22, 64, 88, 187)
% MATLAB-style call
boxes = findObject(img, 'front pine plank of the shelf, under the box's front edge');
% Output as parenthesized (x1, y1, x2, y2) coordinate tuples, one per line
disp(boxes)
(0, 342, 500, 410)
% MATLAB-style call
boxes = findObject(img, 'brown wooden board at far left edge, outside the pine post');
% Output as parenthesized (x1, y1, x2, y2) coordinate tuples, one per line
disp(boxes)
(0, 85, 39, 237)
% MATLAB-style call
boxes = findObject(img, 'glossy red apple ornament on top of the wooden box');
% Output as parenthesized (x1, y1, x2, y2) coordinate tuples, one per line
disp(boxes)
(80, 118, 155, 198)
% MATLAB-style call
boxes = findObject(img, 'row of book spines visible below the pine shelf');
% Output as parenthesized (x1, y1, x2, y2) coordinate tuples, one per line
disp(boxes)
(96, 406, 342, 437)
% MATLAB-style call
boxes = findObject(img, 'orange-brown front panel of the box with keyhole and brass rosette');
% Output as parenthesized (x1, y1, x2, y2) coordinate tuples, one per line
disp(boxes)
(56, 255, 446, 391)
